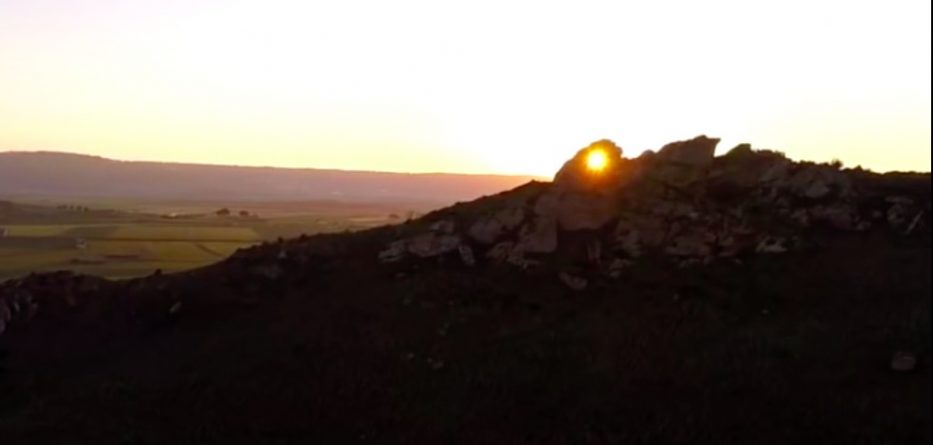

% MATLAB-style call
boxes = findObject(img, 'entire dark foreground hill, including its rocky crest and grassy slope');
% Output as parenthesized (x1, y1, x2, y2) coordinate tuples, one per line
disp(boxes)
(0, 136, 931, 444)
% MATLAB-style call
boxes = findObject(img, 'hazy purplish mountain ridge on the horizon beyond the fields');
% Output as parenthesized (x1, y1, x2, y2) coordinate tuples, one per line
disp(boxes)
(0, 152, 534, 203)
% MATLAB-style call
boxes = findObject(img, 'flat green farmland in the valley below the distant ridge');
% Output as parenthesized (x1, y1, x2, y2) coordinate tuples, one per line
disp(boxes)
(0, 201, 426, 280)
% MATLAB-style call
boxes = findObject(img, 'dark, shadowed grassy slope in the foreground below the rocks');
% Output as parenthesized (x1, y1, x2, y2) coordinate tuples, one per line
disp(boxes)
(0, 225, 931, 445)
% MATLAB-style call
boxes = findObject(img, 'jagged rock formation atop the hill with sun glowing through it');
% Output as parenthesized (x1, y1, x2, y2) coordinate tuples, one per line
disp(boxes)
(380, 136, 930, 288)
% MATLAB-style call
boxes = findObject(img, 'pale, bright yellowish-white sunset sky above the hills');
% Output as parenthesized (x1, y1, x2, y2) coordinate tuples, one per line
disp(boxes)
(0, 0, 931, 176)
